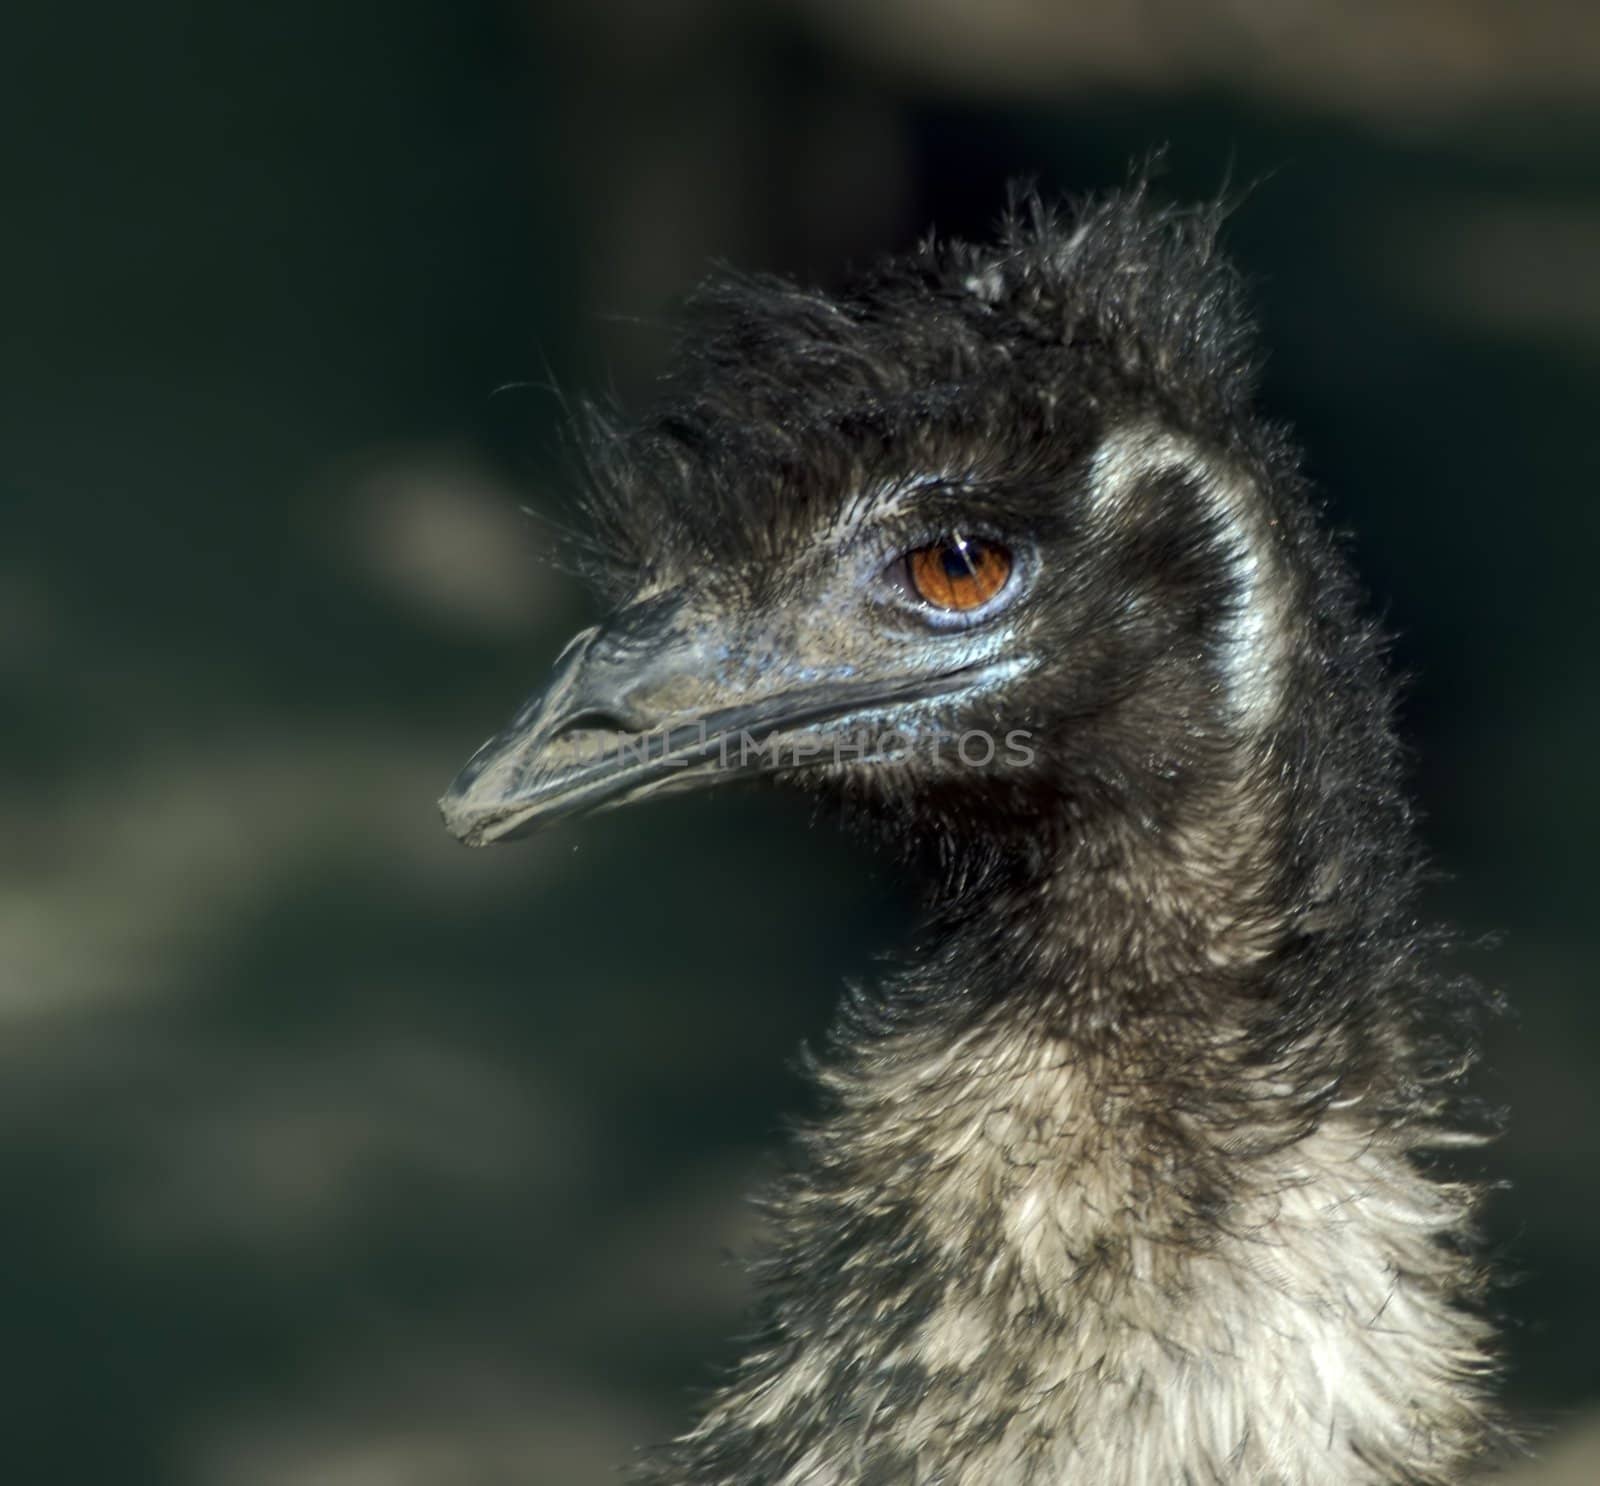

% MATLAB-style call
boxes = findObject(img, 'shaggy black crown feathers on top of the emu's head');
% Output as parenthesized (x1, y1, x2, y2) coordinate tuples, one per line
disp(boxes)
(589, 189, 1259, 587)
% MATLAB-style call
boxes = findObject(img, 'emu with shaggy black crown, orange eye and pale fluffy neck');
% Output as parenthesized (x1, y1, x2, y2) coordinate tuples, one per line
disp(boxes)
(442, 186, 1504, 1486)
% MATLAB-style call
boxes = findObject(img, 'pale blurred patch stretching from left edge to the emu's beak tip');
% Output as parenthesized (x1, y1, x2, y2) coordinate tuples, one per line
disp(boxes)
(0, 729, 531, 1023)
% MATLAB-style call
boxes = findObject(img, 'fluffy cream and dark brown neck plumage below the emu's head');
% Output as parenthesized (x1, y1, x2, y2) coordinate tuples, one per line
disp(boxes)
(633, 726, 1493, 1486)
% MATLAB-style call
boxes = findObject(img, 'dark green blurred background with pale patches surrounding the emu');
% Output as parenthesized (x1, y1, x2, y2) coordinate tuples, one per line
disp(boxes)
(0, 0, 1600, 1486)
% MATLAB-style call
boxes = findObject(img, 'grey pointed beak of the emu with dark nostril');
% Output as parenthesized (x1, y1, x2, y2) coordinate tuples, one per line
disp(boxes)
(438, 595, 973, 846)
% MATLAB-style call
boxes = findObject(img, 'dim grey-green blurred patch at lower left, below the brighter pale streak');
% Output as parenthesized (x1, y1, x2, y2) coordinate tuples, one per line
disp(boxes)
(109, 1037, 594, 1262)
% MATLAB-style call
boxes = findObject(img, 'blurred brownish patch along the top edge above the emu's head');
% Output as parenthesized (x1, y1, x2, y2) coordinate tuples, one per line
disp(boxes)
(797, 0, 1600, 122)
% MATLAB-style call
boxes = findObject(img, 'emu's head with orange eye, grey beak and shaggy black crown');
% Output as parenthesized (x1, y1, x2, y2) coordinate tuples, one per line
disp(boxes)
(443, 192, 1360, 902)
